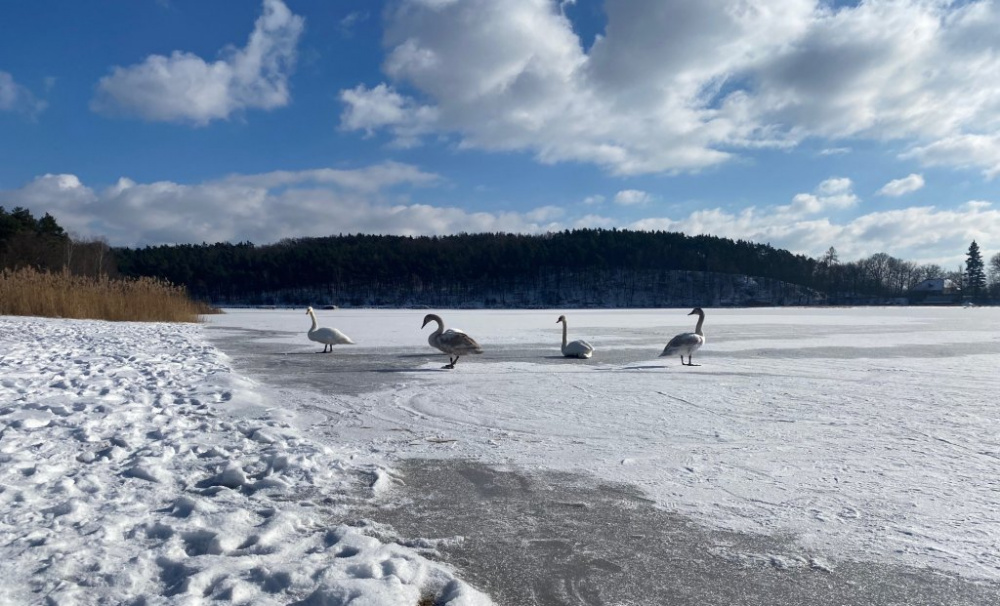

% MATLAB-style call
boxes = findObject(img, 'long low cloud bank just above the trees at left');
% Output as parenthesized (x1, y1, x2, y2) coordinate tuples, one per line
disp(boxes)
(0, 162, 565, 246)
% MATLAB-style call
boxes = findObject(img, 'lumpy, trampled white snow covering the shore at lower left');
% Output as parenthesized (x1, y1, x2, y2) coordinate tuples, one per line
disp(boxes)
(0, 318, 490, 606)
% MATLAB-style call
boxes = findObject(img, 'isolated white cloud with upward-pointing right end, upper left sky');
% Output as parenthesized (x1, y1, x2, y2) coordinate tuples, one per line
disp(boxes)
(91, 0, 304, 125)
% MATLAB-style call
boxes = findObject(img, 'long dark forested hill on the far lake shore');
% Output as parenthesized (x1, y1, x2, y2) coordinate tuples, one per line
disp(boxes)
(115, 229, 960, 306)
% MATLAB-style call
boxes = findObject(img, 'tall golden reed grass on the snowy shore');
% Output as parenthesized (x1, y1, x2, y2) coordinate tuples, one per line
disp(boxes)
(0, 268, 217, 322)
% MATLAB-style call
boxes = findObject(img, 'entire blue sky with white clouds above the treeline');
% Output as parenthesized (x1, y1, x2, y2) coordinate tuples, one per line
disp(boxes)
(0, 0, 1000, 269)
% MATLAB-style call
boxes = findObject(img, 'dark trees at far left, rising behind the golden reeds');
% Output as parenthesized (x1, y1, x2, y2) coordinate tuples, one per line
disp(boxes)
(0, 206, 117, 278)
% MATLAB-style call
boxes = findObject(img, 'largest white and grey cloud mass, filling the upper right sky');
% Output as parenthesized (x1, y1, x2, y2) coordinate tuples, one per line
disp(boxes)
(341, 0, 1000, 176)
